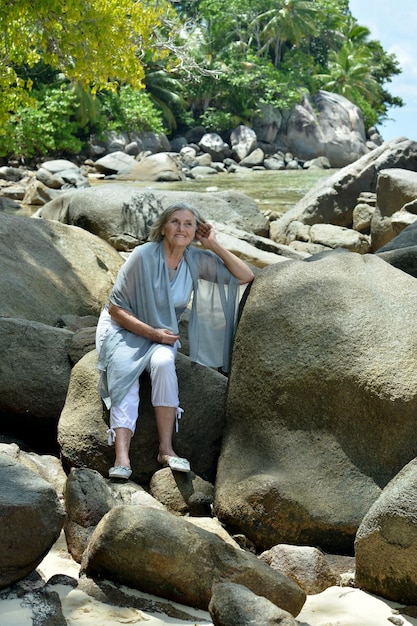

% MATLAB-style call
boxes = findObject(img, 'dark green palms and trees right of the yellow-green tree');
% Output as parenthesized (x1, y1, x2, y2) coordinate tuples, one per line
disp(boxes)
(177, 0, 400, 132)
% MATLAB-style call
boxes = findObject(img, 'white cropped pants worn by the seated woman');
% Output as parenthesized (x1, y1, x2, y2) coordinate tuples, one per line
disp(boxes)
(108, 342, 182, 444)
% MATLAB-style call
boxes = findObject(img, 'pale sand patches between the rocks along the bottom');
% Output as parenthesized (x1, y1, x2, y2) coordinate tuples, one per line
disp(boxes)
(0, 533, 417, 626)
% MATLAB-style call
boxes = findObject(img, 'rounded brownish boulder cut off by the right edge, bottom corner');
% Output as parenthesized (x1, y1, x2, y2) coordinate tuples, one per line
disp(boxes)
(355, 459, 417, 604)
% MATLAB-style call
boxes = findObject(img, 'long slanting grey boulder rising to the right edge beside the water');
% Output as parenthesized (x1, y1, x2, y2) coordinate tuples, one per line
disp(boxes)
(274, 137, 417, 244)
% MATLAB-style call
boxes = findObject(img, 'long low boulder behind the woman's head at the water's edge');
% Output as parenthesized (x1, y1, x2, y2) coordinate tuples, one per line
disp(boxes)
(38, 183, 268, 249)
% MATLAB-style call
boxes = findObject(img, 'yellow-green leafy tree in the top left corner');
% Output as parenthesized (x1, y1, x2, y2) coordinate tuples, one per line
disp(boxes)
(0, 0, 167, 128)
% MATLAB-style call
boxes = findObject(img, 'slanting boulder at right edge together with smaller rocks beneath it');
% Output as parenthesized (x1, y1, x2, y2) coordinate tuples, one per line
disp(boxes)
(270, 137, 417, 254)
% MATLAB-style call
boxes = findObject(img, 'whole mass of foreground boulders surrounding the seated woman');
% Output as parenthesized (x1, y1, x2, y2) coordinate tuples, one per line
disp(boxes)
(0, 132, 417, 626)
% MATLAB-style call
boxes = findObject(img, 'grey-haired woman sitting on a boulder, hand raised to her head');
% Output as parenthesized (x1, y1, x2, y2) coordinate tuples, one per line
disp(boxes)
(97, 203, 254, 479)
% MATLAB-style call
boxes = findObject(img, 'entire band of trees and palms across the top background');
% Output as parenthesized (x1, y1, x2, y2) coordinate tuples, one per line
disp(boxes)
(0, 0, 403, 158)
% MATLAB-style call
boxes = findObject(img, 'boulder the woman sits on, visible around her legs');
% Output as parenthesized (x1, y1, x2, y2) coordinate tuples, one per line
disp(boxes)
(58, 350, 227, 484)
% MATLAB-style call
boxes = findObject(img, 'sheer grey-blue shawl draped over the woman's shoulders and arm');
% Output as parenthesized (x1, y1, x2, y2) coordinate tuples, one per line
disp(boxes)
(97, 242, 240, 408)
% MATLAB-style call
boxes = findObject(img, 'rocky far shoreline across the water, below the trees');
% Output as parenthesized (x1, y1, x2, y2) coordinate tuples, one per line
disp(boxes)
(0, 86, 383, 216)
